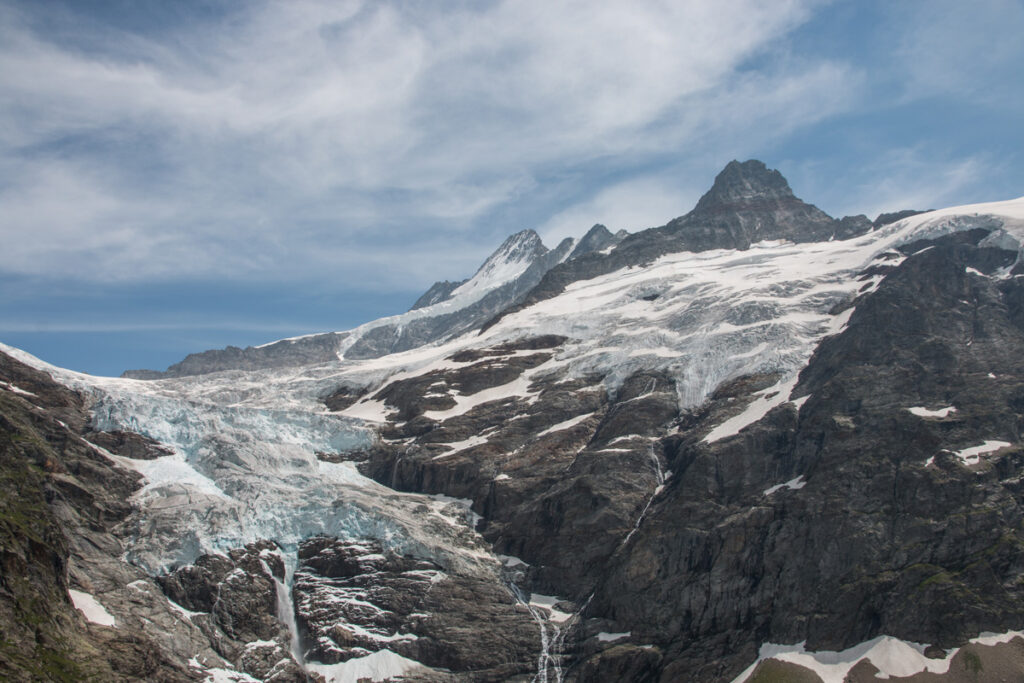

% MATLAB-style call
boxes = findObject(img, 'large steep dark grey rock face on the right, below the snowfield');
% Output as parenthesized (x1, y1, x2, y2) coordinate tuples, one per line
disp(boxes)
(581, 234, 1024, 680)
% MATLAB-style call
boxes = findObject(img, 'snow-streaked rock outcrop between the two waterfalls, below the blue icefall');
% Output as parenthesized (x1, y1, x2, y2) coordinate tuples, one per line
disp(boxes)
(295, 537, 538, 681)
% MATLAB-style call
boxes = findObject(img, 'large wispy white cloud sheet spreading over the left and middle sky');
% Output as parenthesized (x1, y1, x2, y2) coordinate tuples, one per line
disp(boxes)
(0, 0, 856, 287)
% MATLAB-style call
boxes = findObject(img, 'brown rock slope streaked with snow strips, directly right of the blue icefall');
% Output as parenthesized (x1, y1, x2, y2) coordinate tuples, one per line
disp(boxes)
(352, 338, 678, 598)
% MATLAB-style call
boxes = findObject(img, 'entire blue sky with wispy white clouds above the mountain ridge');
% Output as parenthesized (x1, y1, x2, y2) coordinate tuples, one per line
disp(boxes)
(0, 0, 1024, 375)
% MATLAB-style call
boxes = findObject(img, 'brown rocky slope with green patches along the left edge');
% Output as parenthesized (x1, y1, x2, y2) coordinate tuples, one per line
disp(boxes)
(0, 353, 195, 681)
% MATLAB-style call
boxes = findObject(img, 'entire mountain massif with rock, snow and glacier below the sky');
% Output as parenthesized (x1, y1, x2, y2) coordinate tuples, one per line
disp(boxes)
(0, 161, 1024, 683)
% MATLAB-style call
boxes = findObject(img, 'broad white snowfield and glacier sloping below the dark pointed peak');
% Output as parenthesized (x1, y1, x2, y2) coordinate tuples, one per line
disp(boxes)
(338, 198, 1024, 415)
